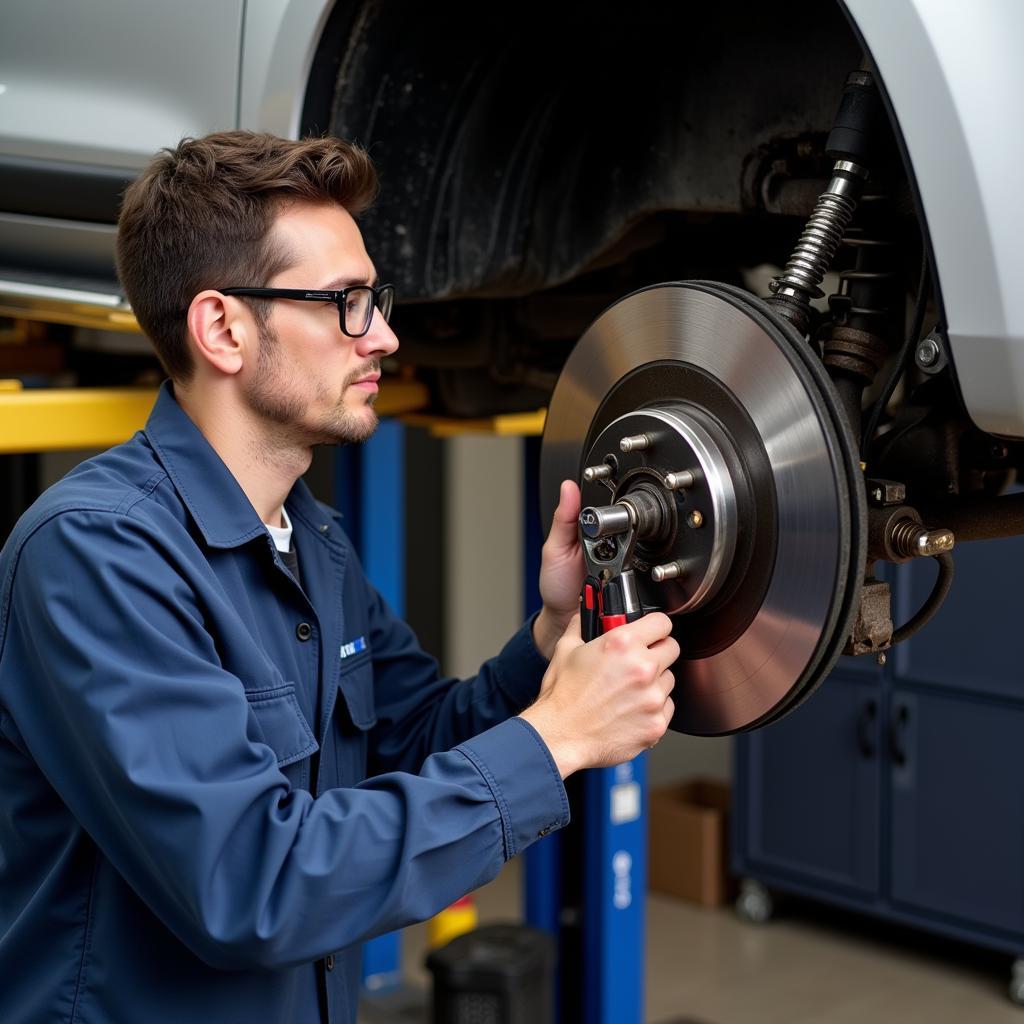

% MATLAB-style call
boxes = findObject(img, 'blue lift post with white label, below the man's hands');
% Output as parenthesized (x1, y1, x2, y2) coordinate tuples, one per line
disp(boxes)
(523, 438, 647, 1024)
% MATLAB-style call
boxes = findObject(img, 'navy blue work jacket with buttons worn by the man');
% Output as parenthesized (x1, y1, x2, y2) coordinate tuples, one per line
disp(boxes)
(0, 385, 568, 1024)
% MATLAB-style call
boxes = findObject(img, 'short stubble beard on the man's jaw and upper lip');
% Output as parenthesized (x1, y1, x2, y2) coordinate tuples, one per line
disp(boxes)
(246, 327, 380, 445)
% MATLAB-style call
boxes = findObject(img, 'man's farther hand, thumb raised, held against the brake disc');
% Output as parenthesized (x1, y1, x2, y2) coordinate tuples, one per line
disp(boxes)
(534, 480, 586, 660)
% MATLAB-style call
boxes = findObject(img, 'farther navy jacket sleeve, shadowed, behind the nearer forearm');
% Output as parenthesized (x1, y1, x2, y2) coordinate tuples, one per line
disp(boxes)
(366, 565, 548, 773)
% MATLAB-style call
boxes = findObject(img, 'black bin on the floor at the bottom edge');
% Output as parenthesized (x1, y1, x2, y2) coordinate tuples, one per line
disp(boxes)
(427, 925, 555, 1024)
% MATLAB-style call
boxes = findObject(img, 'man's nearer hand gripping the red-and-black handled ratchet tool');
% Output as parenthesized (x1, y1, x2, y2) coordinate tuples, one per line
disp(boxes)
(521, 611, 679, 778)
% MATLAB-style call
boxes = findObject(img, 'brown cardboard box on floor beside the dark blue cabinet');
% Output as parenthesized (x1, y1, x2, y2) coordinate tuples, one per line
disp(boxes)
(647, 778, 733, 906)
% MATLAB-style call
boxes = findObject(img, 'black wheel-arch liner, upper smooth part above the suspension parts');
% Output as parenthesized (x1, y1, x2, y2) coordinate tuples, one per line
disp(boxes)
(306, 0, 860, 301)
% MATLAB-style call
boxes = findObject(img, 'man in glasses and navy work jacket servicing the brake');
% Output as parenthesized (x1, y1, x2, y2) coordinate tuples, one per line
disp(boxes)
(0, 131, 679, 1024)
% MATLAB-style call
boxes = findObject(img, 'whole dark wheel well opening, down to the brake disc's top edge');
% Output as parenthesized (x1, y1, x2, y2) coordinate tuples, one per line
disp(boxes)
(306, 0, 921, 415)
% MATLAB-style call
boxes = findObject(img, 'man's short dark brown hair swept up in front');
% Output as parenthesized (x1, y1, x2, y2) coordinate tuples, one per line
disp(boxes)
(117, 131, 377, 383)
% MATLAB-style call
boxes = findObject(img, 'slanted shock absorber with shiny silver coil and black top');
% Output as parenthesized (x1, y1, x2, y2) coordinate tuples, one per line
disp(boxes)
(768, 71, 883, 335)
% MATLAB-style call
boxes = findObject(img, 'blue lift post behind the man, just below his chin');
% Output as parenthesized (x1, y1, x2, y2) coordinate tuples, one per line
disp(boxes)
(344, 420, 406, 992)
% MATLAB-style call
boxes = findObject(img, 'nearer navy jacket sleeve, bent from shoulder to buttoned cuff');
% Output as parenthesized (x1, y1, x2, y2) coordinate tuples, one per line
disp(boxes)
(0, 511, 568, 968)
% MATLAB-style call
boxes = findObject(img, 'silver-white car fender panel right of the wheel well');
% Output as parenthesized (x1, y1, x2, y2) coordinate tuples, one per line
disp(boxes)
(847, 0, 1024, 437)
